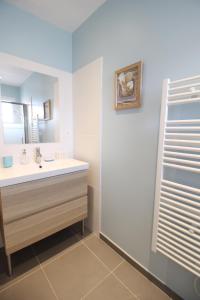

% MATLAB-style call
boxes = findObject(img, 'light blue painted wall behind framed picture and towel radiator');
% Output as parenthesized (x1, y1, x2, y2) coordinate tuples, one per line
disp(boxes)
(73, 0, 200, 300)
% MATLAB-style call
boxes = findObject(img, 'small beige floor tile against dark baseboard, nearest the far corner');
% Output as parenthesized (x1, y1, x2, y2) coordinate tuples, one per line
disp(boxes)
(83, 236, 123, 270)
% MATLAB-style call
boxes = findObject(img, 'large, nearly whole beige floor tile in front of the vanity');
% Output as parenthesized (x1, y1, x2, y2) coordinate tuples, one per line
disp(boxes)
(44, 245, 108, 300)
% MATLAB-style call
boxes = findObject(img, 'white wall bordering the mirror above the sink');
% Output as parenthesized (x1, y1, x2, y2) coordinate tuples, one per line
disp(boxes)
(0, 53, 73, 163)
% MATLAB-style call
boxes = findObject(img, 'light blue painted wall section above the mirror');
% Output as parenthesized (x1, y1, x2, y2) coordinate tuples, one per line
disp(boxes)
(0, 0, 72, 72)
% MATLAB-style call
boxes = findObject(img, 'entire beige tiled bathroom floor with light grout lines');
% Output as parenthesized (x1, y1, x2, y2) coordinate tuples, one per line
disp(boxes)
(0, 229, 169, 300)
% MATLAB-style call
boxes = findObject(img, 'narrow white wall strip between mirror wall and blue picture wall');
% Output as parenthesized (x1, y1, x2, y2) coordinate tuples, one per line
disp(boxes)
(73, 58, 103, 232)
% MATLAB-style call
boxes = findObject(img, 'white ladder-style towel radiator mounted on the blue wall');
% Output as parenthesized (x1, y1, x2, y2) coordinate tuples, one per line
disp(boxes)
(152, 76, 200, 276)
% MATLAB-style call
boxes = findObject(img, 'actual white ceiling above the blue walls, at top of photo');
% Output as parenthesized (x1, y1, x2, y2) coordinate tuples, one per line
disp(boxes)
(6, 0, 106, 32)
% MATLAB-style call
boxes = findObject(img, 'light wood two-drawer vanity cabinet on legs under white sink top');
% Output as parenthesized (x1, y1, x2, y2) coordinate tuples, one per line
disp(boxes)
(0, 171, 88, 274)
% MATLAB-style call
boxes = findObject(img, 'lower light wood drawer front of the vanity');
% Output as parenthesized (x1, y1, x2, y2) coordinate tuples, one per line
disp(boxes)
(4, 197, 87, 254)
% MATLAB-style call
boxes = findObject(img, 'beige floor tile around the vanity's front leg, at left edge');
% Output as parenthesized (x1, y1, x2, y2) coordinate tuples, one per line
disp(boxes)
(0, 247, 40, 290)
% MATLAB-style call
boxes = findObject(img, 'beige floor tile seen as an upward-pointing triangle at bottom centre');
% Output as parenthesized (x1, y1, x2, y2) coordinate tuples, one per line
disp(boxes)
(83, 275, 136, 300)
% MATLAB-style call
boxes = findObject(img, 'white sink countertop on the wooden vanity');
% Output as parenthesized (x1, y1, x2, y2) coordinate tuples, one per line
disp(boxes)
(0, 159, 89, 187)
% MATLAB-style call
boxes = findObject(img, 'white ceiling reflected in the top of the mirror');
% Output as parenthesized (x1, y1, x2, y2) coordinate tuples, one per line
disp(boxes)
(0, 64, 32, 86)
